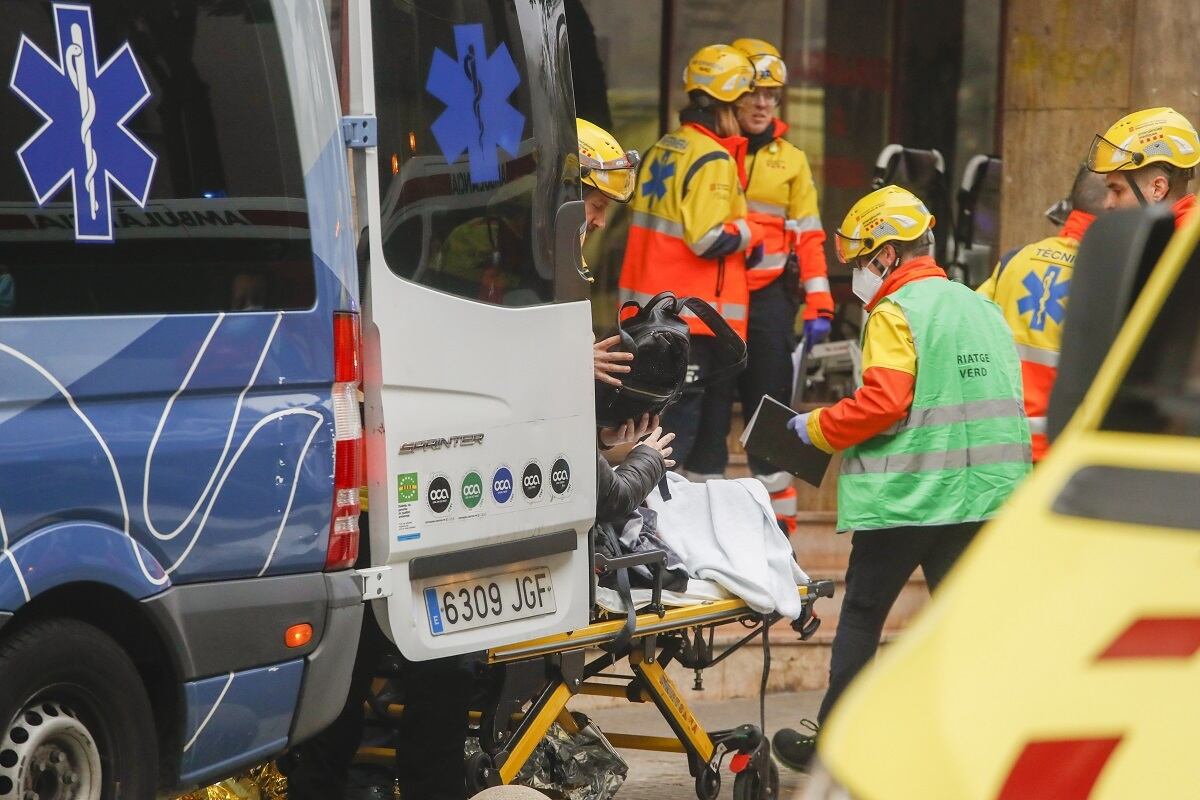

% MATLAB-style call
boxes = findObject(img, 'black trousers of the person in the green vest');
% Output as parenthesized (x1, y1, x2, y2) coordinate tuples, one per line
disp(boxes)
(817, 522, 983, 723)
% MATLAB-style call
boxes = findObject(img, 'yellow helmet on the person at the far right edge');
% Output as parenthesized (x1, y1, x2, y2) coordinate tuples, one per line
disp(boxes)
(1087, 108, 1200, 173)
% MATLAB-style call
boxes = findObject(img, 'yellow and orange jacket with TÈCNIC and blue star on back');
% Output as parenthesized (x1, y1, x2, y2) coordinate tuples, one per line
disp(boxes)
(977, 211, 1096, 462)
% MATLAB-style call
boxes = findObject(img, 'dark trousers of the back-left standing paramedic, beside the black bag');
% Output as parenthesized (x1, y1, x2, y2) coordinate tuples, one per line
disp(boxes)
(662, 336, 737, 474)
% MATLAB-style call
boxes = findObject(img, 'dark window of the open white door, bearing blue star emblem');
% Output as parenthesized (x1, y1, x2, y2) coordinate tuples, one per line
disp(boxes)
(371, 0, 580, 306)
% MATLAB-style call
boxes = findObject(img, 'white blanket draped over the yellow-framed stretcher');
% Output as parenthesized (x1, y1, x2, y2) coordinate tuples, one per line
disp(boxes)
(646, 473, 809, 619)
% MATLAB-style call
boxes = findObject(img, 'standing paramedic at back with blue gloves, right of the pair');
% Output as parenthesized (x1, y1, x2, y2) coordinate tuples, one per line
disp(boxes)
(733, 38, 833, 533)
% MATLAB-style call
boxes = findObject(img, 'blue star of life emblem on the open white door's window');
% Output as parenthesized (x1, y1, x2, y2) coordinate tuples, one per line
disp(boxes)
(425, 24, 524, 184)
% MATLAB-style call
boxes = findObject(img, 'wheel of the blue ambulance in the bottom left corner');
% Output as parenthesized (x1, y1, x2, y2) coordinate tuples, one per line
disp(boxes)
(0, 619, 158, 800)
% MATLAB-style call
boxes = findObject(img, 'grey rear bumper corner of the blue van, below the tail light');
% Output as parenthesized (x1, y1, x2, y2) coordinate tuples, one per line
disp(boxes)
(289, 570, 364, 746)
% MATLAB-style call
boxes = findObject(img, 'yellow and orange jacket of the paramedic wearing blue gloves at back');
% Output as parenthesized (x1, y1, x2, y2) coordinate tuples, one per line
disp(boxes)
(746, 120, 833, 319)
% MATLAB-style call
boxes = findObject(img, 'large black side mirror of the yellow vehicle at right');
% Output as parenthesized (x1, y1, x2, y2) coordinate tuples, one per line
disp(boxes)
(1046, 205, 1175, 443)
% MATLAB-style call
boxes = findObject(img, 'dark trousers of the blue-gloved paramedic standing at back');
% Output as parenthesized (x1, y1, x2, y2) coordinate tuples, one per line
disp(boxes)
(738, 275, 800, 475)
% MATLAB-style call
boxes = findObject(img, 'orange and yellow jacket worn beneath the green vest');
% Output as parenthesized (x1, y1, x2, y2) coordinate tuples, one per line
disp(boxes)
(808, 255, 947, 452)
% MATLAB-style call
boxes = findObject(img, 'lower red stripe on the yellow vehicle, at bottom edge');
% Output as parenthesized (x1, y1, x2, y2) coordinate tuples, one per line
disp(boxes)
(997, 736, 1121, 800)
